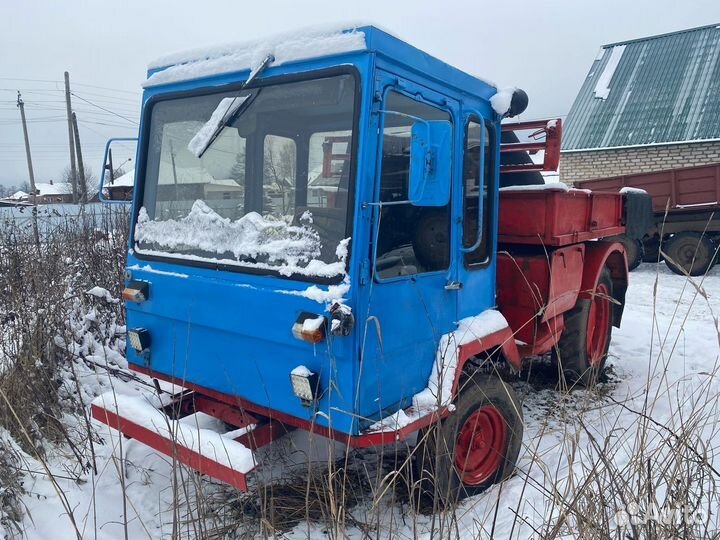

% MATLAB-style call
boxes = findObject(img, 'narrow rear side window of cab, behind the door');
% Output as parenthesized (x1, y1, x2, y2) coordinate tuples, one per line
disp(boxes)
(463, 120, 495, 266)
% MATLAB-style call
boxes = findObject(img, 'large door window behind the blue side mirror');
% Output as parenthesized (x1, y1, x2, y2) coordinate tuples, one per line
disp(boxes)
(375, 92, 451, 278)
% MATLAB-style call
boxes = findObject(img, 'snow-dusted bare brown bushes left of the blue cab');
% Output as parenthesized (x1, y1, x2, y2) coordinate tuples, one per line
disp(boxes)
(0, 209, 127, 532)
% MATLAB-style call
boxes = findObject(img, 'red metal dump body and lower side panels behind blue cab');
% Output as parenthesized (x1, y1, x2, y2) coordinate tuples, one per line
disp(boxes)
(497, 186, 627, 357)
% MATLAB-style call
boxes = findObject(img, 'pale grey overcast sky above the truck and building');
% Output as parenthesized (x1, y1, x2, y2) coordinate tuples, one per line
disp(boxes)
(0, 0, 720, 186)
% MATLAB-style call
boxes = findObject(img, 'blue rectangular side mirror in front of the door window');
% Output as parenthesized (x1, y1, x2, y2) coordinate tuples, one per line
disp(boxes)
(408, 120, 452, 206)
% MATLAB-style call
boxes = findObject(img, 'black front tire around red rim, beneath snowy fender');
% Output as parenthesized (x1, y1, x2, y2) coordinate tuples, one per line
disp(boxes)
(415, 373, 523, 509)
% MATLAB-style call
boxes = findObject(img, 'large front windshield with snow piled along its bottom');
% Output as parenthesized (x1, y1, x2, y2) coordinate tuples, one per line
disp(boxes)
(135, 75, 355, 278)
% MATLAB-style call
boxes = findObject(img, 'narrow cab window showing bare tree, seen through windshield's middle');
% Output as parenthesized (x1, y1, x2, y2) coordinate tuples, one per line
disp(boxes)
(263, 135, 297, 216)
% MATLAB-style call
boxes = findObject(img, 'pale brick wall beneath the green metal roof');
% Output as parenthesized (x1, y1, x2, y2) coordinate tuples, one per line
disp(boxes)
(560, 141, 720, 184)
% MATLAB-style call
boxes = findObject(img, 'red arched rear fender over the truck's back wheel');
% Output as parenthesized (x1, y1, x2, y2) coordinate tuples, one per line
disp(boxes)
(579, 241, 628, 328)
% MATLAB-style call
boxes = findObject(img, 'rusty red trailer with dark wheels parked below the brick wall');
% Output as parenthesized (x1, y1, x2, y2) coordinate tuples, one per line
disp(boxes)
(577, 163, 720, 276)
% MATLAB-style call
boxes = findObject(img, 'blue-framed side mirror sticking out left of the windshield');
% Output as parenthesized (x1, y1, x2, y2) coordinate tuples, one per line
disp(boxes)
(98, 138, 137, 204)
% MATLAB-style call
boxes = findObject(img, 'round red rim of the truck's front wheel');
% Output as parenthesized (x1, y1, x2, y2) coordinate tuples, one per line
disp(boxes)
(455, 405, 507, 486)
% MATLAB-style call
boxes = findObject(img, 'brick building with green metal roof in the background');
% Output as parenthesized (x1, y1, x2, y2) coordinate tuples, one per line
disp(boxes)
(560, 24, 720, 183)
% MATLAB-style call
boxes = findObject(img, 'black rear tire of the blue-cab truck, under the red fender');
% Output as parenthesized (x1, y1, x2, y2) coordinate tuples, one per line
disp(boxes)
(553, 268, 613, 387)
